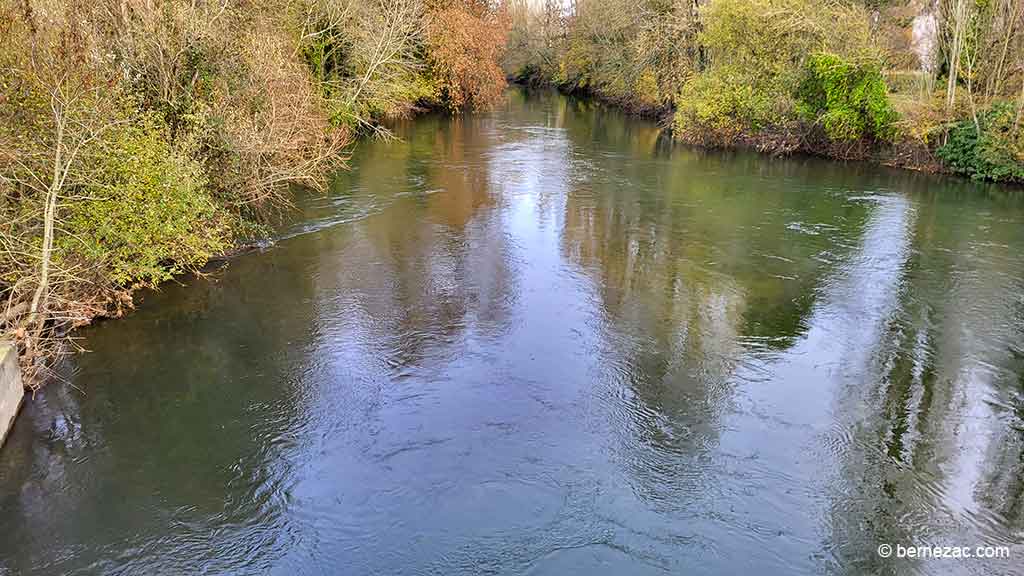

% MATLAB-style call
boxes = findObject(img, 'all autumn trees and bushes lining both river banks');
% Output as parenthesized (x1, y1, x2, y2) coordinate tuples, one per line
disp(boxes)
(0, 0, 1024, 381)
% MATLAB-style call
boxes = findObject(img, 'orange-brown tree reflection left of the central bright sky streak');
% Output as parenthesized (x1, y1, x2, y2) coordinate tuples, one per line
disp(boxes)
(309, 108, 516, 371)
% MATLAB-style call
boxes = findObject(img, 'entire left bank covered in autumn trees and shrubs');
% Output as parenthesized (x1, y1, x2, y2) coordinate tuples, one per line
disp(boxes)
(0, 0, 506, 385)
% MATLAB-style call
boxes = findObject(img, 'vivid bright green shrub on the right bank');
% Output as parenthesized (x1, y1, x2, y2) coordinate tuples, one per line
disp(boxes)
(797, 52, 896, 140)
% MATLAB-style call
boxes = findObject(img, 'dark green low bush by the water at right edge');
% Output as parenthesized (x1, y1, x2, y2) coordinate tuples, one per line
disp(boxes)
(937, 101, 1024, 182)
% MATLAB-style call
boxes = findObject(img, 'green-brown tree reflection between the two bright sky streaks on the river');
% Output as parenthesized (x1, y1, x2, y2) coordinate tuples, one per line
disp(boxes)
(562, 100, 884, 507)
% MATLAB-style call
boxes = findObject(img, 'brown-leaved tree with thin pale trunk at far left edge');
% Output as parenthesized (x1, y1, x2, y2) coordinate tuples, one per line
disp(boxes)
(0, 0, 124, 379)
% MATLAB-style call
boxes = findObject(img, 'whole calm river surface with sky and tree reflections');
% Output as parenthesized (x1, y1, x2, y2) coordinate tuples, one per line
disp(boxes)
(0, 91, 1024, 575)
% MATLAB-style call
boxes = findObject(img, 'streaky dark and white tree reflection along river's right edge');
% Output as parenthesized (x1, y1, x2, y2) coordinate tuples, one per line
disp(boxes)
(831, 172, 1024, 574)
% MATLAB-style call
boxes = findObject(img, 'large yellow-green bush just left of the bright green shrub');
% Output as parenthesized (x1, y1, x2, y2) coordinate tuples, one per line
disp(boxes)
(675, 0, 870, 143)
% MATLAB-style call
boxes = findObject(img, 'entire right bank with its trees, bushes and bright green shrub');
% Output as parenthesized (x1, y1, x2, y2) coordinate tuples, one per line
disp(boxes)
(505, 0, 1024, 184)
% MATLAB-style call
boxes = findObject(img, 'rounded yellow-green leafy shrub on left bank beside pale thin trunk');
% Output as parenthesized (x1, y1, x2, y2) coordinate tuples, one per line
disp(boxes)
(58, 117, 231, 286)
